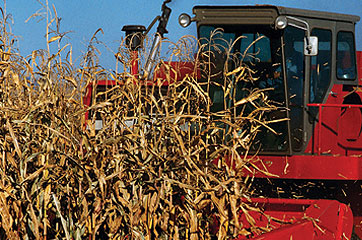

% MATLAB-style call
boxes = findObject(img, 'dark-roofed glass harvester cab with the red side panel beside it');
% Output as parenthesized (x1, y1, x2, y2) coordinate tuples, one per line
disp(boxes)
(184, 6, 362, 155)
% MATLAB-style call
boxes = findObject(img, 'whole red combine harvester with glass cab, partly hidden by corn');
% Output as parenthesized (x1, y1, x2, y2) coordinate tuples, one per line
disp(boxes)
(85, 0, 362, 239)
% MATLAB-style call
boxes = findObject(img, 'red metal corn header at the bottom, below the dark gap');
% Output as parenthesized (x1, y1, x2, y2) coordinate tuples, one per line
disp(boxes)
(238, 198, 353, 240)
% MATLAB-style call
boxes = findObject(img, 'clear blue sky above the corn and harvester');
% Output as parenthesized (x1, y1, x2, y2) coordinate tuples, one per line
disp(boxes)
(1, 0, 362, 69)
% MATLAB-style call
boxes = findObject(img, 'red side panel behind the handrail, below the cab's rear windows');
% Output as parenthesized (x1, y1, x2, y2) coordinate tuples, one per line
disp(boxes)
(306, 85, 362, 156)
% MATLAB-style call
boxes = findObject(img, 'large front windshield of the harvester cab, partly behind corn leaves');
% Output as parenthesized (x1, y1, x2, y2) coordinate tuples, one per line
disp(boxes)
(199, 25, 288, 153)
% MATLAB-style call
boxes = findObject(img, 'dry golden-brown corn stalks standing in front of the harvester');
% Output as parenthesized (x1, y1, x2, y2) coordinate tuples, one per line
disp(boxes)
(0, 2, 279, 240)
